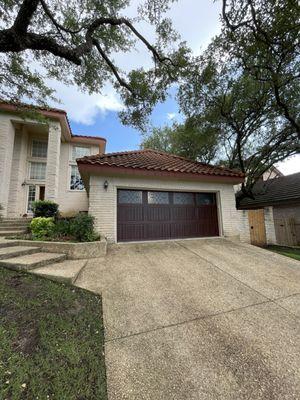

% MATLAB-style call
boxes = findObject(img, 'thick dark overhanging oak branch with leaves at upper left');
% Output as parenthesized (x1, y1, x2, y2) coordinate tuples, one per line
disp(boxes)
(0, 0, 188, 125)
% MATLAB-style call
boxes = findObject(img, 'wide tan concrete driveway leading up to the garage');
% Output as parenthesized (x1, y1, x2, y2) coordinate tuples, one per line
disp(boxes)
(77, 239, 300, 400)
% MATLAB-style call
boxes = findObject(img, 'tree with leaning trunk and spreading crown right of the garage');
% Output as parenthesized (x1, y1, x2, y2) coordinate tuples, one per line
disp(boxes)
(178, 36, 300, 200)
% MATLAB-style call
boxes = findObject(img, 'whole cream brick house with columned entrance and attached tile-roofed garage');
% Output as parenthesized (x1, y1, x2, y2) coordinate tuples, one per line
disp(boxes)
(0, 103, 244, 242)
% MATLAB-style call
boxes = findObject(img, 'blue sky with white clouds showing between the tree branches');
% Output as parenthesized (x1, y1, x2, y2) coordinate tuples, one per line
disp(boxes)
(50, 0, 300, 175)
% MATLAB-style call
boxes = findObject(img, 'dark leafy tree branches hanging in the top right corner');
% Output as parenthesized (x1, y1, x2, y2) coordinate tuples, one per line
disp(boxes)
(222, 0, 300, 138)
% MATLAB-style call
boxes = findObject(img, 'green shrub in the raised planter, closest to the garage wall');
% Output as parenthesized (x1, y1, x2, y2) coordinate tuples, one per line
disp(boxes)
(70, 213, 99, 242)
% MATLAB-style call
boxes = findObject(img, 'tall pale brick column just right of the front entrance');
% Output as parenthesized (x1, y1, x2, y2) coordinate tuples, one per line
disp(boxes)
(45, 121, 61, 202)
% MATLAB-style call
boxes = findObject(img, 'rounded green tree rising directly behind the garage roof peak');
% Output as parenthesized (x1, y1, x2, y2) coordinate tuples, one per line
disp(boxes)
(141, 118, 219, 163)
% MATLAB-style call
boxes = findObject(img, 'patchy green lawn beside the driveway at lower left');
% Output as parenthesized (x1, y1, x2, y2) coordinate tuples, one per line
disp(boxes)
(0, 269, 107, 400)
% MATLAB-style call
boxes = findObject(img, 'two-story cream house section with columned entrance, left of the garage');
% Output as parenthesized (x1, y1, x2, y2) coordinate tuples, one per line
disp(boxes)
(0, 103, 106, 218)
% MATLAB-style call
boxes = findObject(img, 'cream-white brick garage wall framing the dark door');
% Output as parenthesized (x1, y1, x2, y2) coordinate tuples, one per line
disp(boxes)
(89, 175, 239, 242)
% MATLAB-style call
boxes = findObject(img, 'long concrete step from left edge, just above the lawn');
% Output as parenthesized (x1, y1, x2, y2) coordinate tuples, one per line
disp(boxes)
(0, 252, 67, 271)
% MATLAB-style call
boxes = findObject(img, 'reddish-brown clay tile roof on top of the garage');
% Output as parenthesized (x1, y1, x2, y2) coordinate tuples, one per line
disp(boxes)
(77, 149, 244, 181)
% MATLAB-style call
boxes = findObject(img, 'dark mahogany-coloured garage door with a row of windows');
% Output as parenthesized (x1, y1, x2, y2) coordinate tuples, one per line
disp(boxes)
(117, 189, 219, 242)
